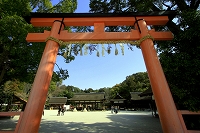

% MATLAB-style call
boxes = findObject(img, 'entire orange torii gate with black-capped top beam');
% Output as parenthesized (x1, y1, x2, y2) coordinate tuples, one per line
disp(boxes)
(15, 11, 187, 133)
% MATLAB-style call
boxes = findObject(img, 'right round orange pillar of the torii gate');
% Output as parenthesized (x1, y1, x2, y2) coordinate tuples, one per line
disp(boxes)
(138, 20, 187, 133)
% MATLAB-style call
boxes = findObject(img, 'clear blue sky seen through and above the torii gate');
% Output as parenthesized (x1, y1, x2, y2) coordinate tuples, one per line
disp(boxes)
(54, 0, 146, 89)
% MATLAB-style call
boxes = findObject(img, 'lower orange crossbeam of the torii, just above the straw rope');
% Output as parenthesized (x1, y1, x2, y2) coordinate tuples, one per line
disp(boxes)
(26, 30, 173, 42)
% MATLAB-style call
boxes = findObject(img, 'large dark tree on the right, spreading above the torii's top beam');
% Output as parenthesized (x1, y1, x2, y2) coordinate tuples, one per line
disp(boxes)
(90, 0, 200, 111)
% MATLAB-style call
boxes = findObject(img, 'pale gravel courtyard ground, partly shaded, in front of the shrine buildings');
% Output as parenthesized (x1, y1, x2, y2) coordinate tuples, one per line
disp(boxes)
(0, 110, 162, 133)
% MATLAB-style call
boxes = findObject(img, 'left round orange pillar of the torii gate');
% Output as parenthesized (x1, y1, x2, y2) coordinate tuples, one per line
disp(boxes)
(15, 21, 64, 133)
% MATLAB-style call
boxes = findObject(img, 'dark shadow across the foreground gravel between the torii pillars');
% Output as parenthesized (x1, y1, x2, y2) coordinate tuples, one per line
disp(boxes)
(39, 114, 162, 133)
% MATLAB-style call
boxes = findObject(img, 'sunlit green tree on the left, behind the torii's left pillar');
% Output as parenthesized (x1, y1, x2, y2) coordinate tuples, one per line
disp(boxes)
(0, 0, 77, 109)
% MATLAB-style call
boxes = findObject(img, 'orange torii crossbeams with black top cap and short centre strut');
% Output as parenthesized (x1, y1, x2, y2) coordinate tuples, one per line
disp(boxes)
(26, 11, 175, 42)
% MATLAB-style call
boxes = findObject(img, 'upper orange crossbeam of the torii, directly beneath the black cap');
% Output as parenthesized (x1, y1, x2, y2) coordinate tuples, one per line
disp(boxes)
(31, 16, 169, 27)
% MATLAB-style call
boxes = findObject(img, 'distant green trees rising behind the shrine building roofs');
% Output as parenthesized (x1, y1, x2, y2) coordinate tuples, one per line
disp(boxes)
(48, 72, 150, 106)
